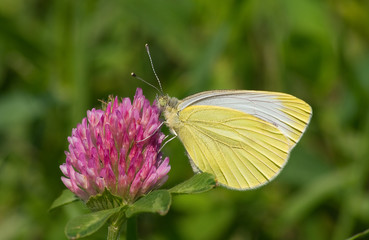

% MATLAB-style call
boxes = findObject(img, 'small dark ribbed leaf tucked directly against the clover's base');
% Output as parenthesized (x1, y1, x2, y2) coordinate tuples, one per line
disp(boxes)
(86, 188, 122, 212)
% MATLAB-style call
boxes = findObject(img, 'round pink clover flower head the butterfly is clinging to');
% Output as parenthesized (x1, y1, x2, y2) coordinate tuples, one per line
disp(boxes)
(60, 89, 170, 203)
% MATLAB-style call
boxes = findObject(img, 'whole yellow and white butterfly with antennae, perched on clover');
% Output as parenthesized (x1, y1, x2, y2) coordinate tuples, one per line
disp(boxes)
(132, 45, 312, 190)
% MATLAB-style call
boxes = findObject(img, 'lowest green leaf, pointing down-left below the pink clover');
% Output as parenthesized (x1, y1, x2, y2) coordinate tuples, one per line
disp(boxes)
(65, 207, 122, 239)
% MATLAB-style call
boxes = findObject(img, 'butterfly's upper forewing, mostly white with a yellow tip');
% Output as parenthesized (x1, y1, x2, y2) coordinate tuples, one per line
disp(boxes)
(178, 90, 312, 149)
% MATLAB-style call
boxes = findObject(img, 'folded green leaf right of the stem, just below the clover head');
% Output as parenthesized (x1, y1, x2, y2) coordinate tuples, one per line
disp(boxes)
(126, 190, 172, 218)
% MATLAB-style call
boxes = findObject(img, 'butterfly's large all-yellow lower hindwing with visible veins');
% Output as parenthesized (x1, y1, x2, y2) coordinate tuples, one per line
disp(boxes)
(172, 105, 290, 190)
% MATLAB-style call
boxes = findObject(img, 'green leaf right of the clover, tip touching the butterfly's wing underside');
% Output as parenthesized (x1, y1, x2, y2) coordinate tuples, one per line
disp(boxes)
(169, 173, 216, 194)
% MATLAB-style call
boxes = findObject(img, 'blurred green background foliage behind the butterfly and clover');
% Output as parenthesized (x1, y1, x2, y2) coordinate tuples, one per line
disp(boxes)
(0, 0, 369, 240)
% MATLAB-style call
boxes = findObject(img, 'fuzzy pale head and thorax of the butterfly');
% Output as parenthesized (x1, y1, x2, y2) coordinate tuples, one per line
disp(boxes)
(157, 95, 181, 134)
